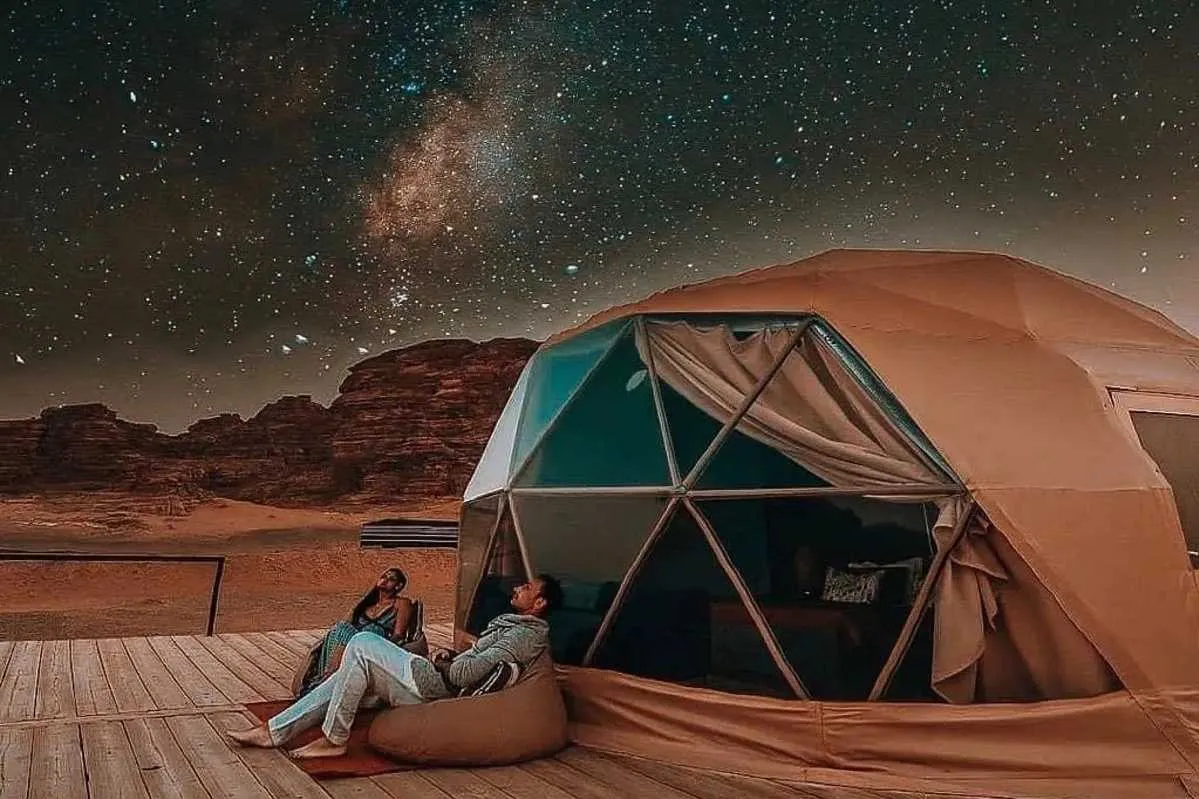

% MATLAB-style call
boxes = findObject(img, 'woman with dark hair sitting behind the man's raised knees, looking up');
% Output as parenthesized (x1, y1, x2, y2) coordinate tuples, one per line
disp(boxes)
(291, 569, 429, 697)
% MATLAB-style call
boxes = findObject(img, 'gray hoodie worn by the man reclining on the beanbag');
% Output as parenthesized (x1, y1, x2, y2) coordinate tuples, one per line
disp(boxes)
(412, 613, 549, 698)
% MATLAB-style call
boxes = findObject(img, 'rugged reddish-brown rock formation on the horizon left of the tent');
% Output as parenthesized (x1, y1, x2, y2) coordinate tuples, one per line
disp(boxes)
(0, 338, 537, 505)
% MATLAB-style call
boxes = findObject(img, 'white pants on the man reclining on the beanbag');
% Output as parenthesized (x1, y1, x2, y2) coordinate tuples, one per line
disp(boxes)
(266, 632, 445, 746)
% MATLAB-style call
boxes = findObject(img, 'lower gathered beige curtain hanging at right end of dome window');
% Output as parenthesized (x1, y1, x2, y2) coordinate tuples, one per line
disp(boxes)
(933, 498, 1120, 704)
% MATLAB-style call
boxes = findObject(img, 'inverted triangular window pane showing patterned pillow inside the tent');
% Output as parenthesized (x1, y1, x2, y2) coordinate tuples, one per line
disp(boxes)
(700, 497, 935, 699)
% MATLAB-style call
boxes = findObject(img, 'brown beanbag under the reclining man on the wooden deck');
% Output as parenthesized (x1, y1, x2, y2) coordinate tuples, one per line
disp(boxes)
(367, 653, 566, 765)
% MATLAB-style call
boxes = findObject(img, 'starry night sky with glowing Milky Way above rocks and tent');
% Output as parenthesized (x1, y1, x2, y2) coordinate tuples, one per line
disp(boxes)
(0, 0, 1199, 431)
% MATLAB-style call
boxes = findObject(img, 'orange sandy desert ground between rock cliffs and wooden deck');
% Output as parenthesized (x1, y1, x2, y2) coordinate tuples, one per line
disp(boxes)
(0, 493, 457, 639)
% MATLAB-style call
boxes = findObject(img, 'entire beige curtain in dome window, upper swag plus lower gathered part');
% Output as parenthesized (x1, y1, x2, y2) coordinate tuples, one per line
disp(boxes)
(637, 322, 1119, 703)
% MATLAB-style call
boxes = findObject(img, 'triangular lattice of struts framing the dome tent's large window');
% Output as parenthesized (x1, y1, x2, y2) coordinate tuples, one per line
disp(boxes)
(456, 314, 966, 701)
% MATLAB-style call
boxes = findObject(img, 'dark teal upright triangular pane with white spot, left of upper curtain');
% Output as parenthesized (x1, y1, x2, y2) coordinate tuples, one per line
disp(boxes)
(514, 329, 671, 487)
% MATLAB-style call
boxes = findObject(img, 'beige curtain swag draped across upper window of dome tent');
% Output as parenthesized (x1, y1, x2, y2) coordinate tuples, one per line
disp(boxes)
(637, 322, 946, 487)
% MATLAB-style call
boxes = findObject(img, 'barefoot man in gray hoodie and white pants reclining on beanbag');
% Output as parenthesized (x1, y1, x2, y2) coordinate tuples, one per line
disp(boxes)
(229, 575, 562, 758)
